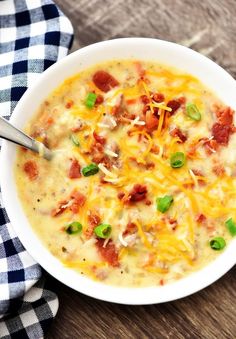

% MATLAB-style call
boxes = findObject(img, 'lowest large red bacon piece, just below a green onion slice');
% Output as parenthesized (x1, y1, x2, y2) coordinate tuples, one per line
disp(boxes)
(96, 239, 119, 267)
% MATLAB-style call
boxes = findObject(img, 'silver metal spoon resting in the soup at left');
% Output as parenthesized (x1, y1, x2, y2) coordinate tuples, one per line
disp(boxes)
(0, 117, 52, 160)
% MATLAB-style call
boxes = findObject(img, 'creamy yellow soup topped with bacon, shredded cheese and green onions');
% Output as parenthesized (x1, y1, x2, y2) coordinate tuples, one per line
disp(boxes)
(15, 60, 236, 286)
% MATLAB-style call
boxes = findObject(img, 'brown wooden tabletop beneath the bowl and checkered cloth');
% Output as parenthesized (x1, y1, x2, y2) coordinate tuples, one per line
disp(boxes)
(47, 0, 236, 339)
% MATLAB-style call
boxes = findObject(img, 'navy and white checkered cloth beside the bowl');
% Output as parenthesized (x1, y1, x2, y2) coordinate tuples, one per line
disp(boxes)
(0, 0, 73, 339)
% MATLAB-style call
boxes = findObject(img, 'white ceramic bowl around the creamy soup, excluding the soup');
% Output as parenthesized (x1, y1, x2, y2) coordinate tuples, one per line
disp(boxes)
(0, 38, 236, 304)
